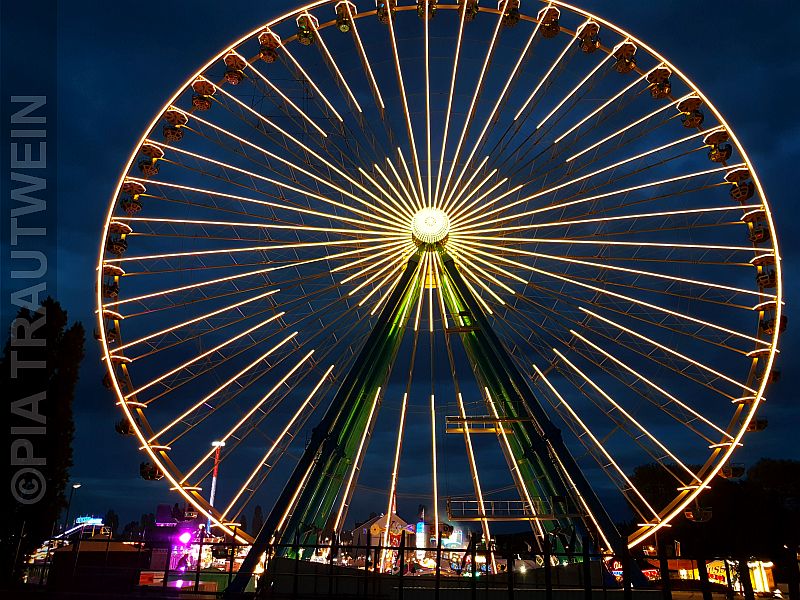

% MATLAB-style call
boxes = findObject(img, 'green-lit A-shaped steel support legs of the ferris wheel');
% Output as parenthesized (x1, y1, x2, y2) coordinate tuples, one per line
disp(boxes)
(231, 248, 627, 597)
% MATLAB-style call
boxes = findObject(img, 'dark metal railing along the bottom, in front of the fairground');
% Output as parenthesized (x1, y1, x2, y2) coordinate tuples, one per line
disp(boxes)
(20, 536, 800, 600)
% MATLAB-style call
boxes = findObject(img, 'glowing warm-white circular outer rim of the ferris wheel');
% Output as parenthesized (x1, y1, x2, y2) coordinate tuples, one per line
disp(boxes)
(96, 0, 783, 546)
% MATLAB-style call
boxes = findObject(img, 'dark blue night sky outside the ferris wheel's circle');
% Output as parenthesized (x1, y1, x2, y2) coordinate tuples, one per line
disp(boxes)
(47, 0, 800, 523)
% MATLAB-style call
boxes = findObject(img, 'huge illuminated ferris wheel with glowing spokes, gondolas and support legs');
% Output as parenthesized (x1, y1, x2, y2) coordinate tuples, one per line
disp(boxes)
(97, 0, 786, 564)
